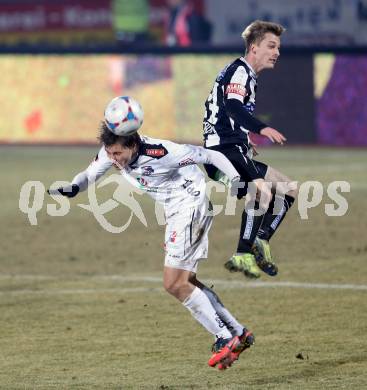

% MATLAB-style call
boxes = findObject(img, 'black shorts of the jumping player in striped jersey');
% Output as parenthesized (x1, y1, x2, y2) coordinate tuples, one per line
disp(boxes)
(204, 144, 268, 197)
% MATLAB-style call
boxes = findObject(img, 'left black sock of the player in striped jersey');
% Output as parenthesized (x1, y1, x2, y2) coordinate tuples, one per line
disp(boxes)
(237, 202, 264, 253)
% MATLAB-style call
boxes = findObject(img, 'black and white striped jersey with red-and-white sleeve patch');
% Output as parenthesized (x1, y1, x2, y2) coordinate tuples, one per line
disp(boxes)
(203, 57, 257, 147)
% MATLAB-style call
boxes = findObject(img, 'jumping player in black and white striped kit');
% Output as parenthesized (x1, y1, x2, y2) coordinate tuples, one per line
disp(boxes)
(203, 20, 297, 278)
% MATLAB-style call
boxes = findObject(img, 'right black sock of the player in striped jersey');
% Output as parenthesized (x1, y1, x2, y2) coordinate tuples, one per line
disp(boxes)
(257, 195, 294, 241)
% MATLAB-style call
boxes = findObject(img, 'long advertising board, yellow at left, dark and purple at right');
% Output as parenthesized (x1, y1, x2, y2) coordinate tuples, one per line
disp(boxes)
(0, 54, 367, 146)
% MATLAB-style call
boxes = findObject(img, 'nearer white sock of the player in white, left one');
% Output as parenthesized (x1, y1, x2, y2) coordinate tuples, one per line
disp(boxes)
(182, 287, 232, 339)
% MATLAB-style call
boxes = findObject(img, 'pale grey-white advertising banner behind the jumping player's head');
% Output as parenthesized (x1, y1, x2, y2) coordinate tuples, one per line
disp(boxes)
(206, 0, 367, 46)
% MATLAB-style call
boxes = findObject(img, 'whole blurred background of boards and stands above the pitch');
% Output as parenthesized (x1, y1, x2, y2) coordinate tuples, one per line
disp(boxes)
(0, 0, 367, 146)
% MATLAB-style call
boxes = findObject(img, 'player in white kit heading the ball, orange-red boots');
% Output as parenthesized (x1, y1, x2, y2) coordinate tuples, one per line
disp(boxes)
(49, 123, 254, 369)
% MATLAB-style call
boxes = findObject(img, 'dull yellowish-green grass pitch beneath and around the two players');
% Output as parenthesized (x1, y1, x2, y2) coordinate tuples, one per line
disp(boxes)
(0, 147, 367, 390)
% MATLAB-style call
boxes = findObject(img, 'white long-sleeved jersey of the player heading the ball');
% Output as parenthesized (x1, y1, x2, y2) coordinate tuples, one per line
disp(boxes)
(72, 136, 238, 212)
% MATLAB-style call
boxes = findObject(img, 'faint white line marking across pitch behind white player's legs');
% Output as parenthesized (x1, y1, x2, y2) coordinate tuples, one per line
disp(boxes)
(0, 274, 367, 296)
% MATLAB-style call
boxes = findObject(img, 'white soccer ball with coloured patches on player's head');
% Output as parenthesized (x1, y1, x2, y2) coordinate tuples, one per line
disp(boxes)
(104, 96, 144, 136)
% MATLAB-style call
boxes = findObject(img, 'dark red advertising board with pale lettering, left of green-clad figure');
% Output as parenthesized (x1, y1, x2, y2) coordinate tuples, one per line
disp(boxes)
(0, 0, 114, 45)
